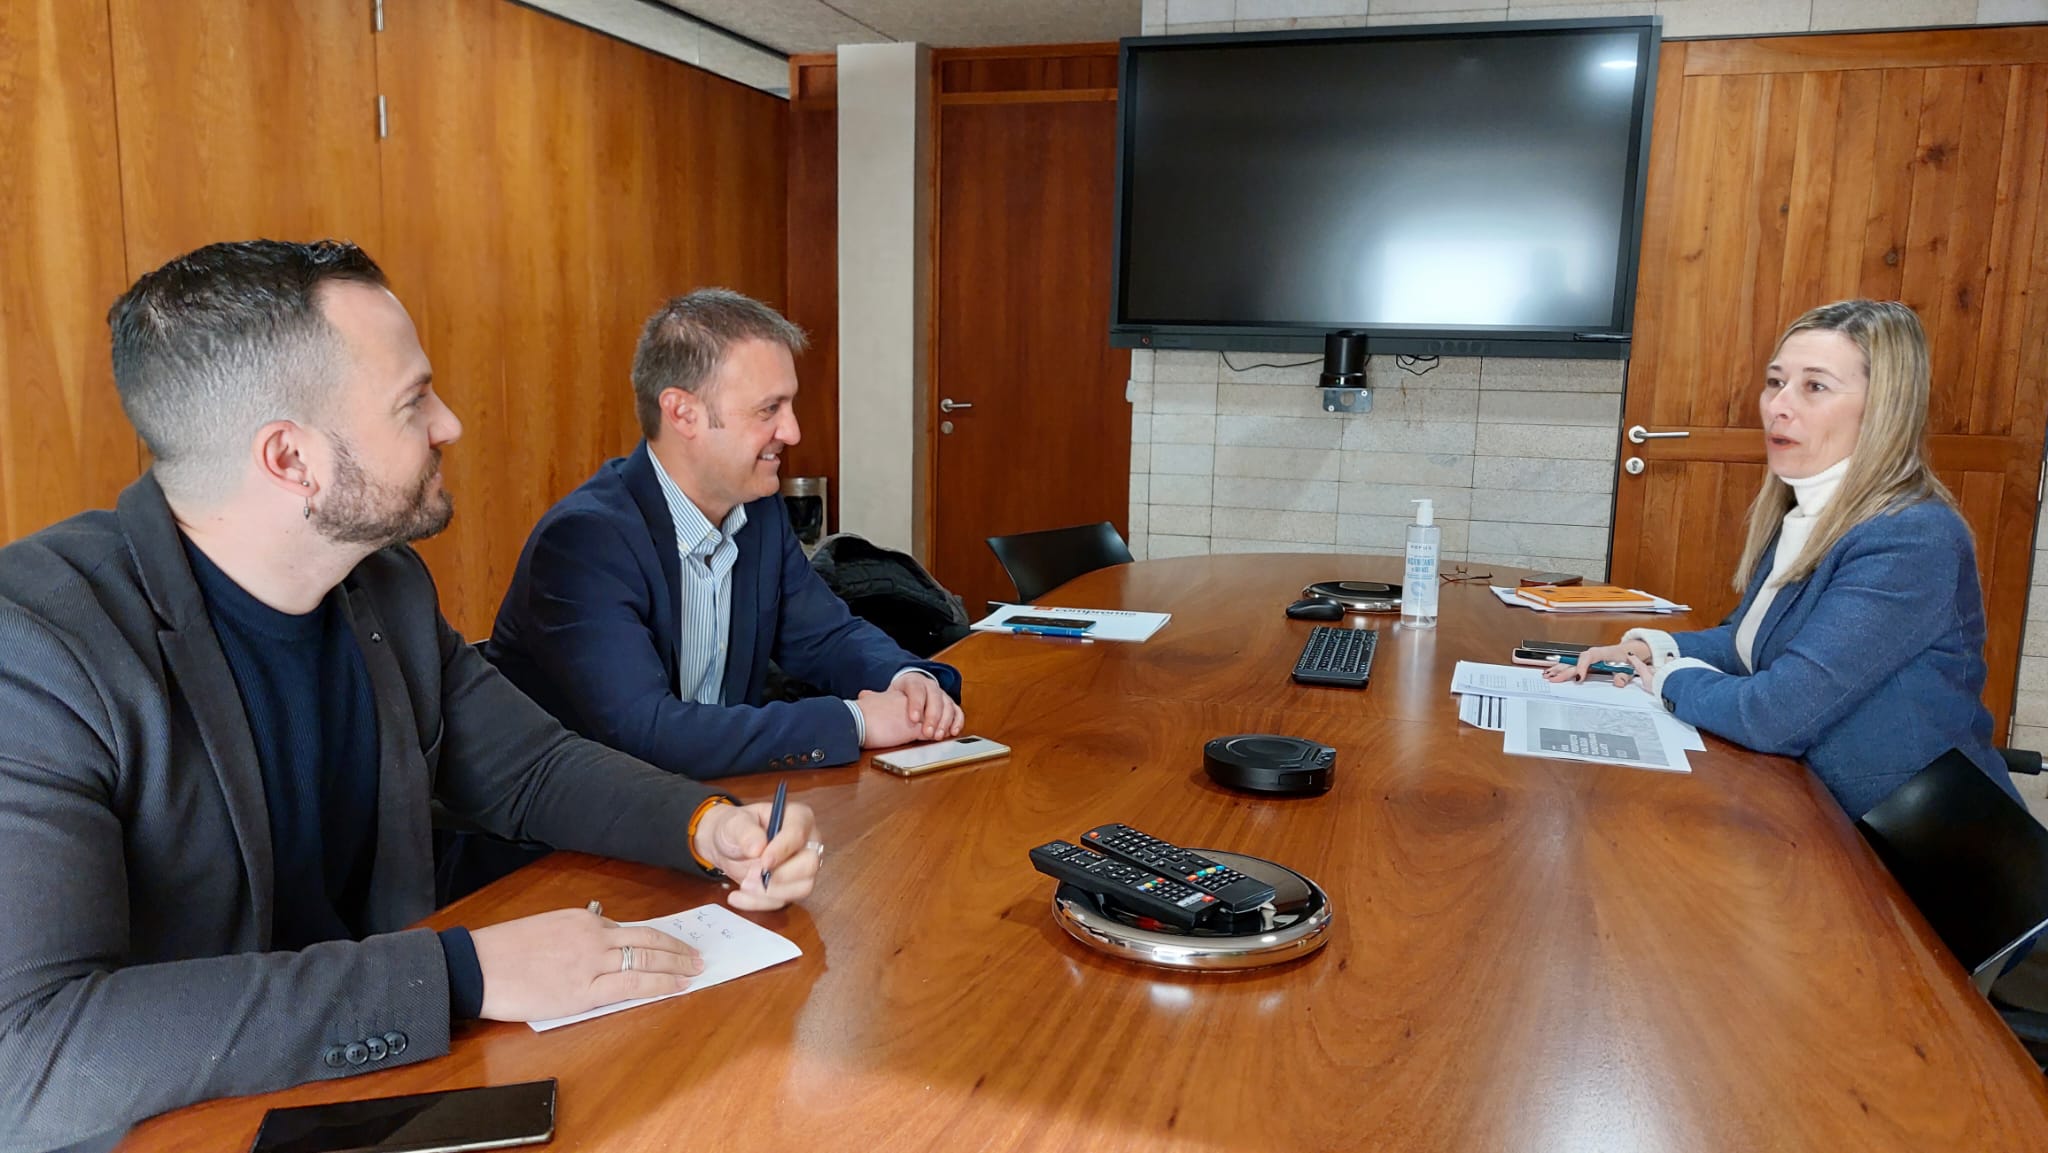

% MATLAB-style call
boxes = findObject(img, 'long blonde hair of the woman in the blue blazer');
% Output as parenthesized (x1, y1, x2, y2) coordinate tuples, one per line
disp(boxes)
(1735, 301, 1956, 592)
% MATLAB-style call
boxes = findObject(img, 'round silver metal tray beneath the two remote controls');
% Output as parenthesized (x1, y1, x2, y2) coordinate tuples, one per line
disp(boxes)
(1053, 848, 1331, 969)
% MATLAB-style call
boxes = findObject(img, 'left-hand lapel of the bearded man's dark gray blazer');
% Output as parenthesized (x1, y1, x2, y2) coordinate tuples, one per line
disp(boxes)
(117, 473, 276, 948)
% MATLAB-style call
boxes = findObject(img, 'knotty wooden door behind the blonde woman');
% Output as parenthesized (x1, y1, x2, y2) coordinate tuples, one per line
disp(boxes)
(1614, 36, 2048, 739)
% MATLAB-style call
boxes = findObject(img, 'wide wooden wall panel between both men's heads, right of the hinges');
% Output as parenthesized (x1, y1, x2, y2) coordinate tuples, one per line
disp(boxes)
(377, 0, 786, 639)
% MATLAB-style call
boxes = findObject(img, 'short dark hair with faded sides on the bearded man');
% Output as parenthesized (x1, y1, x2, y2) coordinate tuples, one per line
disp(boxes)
(106, 240, 385, 500)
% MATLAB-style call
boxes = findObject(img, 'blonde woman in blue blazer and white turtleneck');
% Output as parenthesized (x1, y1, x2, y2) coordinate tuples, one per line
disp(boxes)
(1546, 301, 2017, 817)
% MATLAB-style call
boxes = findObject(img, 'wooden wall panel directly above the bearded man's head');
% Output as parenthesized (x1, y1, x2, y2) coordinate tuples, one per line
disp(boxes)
(106, 0, 383, 276)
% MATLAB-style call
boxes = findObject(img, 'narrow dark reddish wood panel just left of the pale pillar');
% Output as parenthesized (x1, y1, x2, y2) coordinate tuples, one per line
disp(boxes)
(782, 53, 840, 528)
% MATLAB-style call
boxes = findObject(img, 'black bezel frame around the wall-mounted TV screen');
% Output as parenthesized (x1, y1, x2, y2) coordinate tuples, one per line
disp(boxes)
(1110, 16, 1663, 360)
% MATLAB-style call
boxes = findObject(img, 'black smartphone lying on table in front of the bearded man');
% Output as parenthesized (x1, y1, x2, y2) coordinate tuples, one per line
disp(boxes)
(250, 1077, 555, 1153)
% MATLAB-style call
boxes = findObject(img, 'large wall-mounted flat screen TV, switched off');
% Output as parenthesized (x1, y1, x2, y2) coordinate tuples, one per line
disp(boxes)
(1110, 16, 1659, 356)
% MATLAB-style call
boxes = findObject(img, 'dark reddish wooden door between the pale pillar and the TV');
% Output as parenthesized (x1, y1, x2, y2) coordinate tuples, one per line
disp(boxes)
(928, 45, 1130, 616)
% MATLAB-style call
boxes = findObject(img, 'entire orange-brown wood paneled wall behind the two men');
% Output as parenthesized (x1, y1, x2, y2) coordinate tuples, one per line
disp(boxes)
(0, 0, 788, 637)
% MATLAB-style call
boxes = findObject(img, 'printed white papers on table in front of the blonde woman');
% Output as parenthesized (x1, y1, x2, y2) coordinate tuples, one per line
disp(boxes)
(1450, 661, 1706, 772)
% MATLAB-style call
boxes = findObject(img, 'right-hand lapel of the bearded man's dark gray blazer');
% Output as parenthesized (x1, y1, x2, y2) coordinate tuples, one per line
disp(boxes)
(344, 586, 438, 932)
